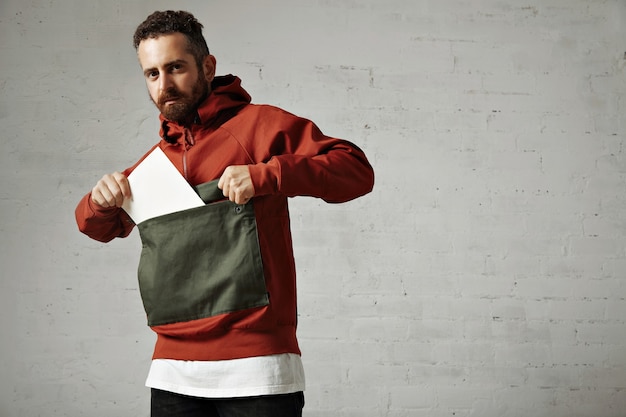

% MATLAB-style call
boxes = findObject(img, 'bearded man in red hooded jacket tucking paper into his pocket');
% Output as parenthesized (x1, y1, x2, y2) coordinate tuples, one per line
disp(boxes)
(76, 11, 374, 417)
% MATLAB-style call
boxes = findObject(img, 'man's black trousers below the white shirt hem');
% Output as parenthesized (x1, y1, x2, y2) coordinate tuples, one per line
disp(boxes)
(150, 388, 304, 417)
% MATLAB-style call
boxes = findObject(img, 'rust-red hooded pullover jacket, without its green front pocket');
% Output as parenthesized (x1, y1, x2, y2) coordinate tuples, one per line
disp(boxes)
(76, 75, 374, 360)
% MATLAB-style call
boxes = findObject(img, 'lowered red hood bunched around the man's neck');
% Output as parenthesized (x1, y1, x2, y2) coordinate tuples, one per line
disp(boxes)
(159, 75, 251, 144)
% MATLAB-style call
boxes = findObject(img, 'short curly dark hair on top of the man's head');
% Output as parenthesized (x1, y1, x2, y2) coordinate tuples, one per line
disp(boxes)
(133, 10, 209, 63)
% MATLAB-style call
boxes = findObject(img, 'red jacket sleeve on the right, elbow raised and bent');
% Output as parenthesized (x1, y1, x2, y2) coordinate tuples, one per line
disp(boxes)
(250, 107, 374, 203)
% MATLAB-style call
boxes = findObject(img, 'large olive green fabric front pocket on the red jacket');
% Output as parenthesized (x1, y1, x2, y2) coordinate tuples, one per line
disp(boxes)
(138, 182, 269, 326)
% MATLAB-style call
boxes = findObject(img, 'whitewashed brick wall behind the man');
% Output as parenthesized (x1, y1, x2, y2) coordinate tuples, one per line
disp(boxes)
(0, 0, 626, 417)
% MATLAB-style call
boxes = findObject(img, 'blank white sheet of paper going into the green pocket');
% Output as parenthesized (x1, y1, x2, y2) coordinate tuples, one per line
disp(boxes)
(122, 147, 204, 224)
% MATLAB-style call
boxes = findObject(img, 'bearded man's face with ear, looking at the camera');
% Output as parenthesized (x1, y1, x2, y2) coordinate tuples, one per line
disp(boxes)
(137, 33, 215, 123)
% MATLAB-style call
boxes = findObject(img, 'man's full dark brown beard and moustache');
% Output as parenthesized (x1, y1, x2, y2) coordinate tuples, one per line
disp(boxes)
(153, 76, 209, 124)
